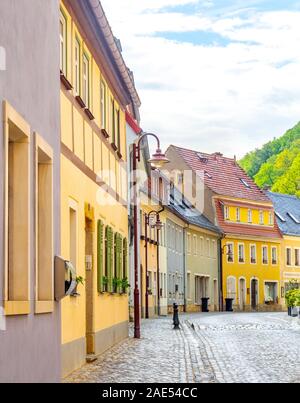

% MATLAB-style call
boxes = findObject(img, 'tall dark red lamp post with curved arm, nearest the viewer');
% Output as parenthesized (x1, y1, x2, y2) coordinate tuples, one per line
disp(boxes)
(132, 133, 169, 339)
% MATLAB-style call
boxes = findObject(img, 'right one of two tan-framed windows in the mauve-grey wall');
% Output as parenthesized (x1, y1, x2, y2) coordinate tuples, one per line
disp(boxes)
(35, 134, 53, 313)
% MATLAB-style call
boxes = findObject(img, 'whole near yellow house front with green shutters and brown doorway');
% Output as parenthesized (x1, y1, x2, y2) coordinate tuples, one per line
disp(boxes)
(60, 1, 140, 376)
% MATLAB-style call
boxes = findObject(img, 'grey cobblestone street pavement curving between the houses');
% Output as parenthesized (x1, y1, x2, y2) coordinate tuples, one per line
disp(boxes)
(66, 313, 300, 383)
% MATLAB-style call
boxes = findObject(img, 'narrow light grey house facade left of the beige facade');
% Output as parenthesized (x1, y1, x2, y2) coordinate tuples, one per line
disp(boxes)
(166, 218, 185, 306)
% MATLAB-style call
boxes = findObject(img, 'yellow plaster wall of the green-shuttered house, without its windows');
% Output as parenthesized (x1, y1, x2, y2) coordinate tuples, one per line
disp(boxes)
(61, 1, 129, 376)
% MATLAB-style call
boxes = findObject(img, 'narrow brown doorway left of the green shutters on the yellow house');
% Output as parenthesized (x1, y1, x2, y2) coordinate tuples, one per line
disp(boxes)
(85, 218, 95, 355)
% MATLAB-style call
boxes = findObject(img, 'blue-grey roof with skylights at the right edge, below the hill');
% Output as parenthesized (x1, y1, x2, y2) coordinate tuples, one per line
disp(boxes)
(268, 192, 300, 236)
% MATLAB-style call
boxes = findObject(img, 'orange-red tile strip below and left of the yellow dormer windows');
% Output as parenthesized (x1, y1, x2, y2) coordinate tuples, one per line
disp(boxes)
(215, 199, 281, 239)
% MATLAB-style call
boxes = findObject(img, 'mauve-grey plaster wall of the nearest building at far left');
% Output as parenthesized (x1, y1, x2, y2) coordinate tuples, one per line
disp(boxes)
(0, 0, 60, 382)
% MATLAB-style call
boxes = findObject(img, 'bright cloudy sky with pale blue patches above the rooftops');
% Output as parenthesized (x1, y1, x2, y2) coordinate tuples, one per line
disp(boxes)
(101, 0, 300, 158)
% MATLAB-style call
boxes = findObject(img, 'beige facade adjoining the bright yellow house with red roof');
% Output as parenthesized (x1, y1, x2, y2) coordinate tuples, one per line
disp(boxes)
(186, 227, 219, 311)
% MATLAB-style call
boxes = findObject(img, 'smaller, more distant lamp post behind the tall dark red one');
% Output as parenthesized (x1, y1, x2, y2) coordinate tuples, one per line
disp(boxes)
(145, 208, 164, 319)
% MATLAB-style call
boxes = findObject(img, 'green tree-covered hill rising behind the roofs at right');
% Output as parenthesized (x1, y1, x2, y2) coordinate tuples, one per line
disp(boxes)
(239, 122, 300, 197)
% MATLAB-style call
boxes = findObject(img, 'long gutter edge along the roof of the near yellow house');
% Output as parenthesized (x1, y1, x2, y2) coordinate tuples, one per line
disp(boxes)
(87, 0, 141, 107)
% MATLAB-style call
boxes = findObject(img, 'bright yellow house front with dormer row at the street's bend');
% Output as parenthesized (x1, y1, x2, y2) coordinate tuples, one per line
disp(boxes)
(216, 198, 282, 311)
